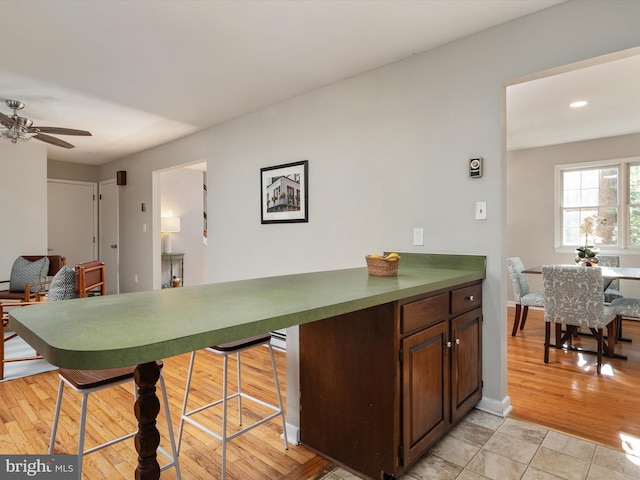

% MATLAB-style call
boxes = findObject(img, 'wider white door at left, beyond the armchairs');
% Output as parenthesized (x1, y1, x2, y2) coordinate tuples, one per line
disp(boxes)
(47, 179, 98, 267)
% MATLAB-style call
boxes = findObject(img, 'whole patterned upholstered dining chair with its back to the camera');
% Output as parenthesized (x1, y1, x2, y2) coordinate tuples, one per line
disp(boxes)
(542, 265, 616, 374)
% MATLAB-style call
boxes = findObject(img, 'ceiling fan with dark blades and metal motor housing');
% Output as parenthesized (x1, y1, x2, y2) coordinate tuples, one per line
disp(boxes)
(0, 100, 91, 148)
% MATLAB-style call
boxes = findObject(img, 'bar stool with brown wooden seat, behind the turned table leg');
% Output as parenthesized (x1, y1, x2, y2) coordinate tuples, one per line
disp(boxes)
(49, 362, 181, 480)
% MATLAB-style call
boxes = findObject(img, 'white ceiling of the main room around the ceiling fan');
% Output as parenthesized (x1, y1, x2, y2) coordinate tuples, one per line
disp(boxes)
(0, 0, 584, 165)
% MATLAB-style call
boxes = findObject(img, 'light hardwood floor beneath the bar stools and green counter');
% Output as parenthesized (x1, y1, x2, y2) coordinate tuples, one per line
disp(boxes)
(0, 348, 333, 480)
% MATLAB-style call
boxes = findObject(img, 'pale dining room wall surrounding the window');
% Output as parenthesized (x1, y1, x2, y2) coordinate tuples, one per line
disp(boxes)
(507, 131, 640, 301)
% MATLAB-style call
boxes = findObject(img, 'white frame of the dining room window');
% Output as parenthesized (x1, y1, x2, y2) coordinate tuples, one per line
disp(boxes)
(553, 157, 640, 254)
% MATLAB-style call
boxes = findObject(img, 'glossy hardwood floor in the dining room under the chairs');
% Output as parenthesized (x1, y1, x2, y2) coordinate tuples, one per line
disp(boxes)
(507, 308, 640, 455)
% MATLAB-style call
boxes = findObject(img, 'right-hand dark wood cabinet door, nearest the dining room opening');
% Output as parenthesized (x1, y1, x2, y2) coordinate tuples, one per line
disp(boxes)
(451, 308, 482, 423)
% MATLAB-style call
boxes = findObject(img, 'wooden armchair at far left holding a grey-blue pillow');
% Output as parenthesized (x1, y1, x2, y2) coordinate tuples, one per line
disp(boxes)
(0, 255, 67, 302)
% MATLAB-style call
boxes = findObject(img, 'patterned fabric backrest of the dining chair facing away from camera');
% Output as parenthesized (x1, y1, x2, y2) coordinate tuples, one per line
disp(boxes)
(542, 265, 609, 328)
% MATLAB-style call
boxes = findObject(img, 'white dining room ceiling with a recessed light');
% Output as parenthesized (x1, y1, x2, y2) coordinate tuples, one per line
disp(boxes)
(507, 49, 640, 150)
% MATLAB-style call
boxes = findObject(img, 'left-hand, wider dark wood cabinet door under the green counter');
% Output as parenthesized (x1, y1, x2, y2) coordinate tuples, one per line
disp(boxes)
(402, 322, 451, 466)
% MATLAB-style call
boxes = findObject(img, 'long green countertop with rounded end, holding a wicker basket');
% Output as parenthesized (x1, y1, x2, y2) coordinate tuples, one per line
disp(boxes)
(10, 253, 486, 369)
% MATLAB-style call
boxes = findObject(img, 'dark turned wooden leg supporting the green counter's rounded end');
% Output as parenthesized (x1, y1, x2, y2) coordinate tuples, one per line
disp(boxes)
(134, 362, 160, 480)
